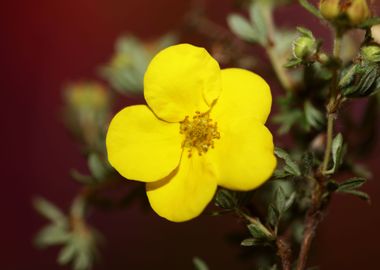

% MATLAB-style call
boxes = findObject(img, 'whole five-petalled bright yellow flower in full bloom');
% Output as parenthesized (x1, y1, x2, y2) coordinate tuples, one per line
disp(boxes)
(106, 44, 276, 222)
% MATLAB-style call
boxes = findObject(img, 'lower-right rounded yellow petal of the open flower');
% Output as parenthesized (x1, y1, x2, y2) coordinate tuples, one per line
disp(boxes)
(207, 117, 277, 191)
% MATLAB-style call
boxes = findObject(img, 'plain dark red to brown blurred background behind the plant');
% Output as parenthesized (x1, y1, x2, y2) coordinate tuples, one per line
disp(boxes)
(0, 0, 380, 270)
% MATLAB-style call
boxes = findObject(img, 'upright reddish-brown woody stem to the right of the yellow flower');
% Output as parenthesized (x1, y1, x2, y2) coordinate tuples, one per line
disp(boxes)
(296, 33, 342, 270)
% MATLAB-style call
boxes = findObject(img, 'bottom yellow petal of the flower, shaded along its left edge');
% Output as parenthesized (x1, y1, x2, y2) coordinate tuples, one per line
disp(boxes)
(147, 155, 217, 222)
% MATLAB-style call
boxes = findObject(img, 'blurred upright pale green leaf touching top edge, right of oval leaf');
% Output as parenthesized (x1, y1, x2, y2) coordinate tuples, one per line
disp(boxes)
(249, 2, 269, 45)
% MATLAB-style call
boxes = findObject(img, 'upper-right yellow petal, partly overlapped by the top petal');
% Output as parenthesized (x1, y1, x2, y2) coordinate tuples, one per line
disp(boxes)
(211, 68, 272, 125)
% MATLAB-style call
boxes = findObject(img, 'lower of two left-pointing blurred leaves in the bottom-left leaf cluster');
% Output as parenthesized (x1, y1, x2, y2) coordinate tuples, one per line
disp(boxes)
(35, 224, 71, 248)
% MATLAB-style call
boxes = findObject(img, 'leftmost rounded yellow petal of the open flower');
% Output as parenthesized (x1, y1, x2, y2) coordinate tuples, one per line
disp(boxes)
(106, 105, 182, 182)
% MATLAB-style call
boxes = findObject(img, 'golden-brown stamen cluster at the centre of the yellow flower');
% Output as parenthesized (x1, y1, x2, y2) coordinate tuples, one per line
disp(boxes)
(180, 112, 220, 157)
